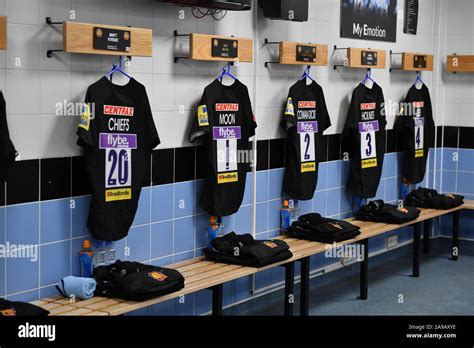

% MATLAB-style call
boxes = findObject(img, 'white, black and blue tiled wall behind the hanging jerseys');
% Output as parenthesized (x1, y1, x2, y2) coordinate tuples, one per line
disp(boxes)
(0, 0, 470, 314)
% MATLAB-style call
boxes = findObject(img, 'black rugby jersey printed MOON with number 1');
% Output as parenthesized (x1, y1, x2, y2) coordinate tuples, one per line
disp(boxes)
(189, 80, 257, 216)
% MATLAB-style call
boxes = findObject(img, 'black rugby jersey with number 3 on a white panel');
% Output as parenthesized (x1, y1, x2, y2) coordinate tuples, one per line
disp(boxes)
(343, 82, 387, 198)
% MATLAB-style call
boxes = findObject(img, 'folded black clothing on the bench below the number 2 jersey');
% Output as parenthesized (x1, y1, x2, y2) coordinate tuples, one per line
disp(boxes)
(287, 213, 360, 243)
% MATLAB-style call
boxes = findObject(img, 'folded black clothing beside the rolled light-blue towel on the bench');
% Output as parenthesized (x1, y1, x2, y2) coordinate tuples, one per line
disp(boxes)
(93, 260, 184, 301)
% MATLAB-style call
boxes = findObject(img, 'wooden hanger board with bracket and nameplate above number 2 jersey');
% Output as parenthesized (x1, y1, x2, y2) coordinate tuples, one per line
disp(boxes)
(265, 39, 328, 68)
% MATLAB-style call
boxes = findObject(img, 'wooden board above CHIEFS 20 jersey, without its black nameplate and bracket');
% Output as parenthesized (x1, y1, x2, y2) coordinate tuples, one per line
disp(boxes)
(63, 22, 153, 57)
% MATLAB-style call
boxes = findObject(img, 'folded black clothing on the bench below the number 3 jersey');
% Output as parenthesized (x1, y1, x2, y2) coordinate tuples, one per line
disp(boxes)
(355, 199, 420, 224)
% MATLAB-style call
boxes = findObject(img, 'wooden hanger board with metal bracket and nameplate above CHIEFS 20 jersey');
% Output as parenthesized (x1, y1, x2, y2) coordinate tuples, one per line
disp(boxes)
(46, 17, 153, 59)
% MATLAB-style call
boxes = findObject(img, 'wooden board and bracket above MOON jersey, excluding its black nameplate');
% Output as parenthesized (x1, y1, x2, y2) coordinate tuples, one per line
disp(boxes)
(175, 33, 253, 63)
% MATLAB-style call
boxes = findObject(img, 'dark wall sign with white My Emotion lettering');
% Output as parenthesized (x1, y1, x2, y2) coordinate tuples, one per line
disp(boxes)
(341, 0, 397, 42)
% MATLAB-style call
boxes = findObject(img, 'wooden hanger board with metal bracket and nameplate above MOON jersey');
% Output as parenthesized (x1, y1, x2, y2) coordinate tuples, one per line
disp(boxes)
(173, 30, 253, 63)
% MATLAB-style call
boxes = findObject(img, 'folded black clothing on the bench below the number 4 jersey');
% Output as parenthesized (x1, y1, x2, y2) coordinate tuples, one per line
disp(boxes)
(405, 187, 464, 209)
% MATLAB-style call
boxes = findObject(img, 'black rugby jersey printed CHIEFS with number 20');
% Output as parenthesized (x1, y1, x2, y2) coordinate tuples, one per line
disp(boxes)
(77, 77, 160, 241)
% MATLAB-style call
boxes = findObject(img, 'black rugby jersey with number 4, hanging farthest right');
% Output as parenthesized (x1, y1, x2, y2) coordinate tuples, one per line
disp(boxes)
(395, 84, 435, 184)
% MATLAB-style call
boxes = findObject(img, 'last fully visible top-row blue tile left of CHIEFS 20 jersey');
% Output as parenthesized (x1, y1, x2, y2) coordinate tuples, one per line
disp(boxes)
(40, 199, 71, 243)
